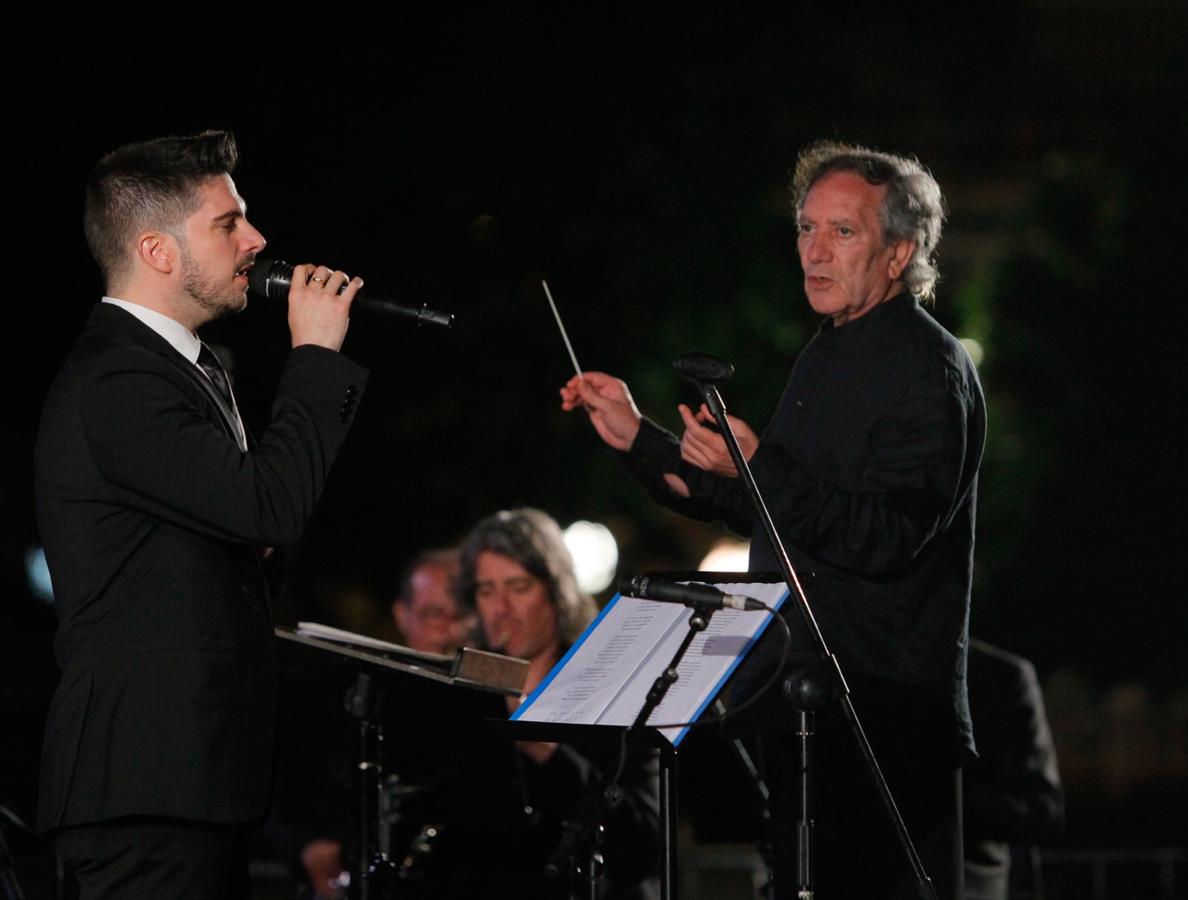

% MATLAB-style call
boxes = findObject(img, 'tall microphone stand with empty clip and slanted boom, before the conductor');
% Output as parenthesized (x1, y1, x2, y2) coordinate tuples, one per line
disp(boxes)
(693, 375, 937, 900)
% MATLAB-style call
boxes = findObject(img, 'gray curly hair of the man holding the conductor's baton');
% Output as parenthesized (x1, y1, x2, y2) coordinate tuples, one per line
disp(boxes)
(792, 141, 946, 300)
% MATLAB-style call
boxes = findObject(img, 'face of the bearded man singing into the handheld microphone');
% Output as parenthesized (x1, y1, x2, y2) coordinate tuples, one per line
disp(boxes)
(178, 175, 265, 324)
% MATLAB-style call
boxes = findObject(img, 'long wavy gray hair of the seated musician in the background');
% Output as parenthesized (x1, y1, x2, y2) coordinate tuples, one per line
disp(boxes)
(457, 507, 598, 647)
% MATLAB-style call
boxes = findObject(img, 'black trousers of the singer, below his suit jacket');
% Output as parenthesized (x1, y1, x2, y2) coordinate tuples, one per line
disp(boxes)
(53, 817, 251, 900)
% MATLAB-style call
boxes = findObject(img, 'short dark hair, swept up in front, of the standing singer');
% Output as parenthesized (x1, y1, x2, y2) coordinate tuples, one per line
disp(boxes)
(82, 131, 239, 287)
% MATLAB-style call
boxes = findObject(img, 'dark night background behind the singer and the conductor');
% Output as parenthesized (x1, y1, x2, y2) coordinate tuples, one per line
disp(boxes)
(0, 0, 1188, 883)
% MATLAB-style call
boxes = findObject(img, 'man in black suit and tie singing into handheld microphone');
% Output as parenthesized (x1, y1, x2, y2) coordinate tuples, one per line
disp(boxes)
(36, 132, 366, 900)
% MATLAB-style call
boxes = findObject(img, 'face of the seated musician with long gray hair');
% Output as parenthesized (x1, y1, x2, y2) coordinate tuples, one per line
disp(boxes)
(474, 550, 560, 659)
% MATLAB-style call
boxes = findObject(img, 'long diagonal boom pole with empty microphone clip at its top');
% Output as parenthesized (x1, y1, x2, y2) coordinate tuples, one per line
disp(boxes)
(678, 379, 937, 900)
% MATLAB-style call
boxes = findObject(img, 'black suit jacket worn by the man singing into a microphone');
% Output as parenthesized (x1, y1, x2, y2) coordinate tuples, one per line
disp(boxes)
(36, 304, 366, 830)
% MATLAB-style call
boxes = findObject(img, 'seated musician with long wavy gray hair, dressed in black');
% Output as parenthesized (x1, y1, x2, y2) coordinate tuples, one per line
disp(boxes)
(288, 509, 659, 900)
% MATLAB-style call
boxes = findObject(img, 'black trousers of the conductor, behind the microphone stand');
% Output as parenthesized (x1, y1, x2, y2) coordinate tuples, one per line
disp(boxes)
(762, 714, 963, 900)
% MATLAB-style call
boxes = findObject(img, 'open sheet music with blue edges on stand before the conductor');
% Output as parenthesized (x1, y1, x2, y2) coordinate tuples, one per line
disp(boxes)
(512, 583, 788, 744)
